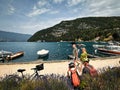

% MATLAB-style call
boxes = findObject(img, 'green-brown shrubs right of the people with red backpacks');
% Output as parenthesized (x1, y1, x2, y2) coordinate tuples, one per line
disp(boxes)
(80, 67, 120, 90)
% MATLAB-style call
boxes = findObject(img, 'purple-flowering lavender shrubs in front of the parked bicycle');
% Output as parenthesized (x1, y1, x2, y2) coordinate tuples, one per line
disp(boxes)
(0, 74, 69, 90)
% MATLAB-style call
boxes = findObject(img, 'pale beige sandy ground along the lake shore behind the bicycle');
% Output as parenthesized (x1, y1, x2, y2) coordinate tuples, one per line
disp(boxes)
(0, 57, 120, 77)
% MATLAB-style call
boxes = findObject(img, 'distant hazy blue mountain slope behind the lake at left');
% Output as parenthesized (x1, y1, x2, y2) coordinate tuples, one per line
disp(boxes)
(0, 31, 31, 42)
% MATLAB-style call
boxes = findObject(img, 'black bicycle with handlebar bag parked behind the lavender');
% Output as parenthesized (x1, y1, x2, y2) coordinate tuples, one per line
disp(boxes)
(5, 63, 44, 83)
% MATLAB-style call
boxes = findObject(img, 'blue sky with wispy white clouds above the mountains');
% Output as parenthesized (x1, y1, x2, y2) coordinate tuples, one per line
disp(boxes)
(0, 0, 120, 35)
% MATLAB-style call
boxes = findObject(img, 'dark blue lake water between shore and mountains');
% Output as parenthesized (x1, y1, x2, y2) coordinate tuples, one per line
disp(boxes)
(0, 42, 106, 62)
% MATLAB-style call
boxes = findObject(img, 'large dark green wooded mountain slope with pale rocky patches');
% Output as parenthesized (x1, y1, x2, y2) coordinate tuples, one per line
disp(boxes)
(28, 17, 120, 41)
